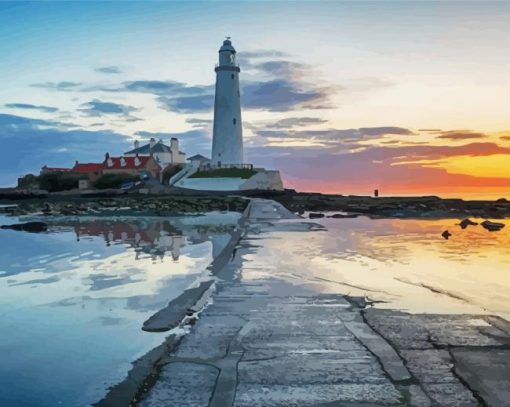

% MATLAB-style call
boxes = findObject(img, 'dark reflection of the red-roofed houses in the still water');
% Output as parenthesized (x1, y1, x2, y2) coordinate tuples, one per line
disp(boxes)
(69, 220, 234, 261)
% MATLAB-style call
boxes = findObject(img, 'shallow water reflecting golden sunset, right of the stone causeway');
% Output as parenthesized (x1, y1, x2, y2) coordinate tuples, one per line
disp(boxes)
(243, 217, 510, 320)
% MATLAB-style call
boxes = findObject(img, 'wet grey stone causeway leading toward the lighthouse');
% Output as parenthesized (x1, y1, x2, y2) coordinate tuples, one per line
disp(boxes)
(136, 200, 510, 407)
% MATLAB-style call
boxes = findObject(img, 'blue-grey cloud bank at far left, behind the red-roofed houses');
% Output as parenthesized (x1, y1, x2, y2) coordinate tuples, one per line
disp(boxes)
(0, 114, 130, 186)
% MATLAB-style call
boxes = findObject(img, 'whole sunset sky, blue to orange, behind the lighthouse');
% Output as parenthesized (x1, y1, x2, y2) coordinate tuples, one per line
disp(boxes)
(0, 0, 510, 198)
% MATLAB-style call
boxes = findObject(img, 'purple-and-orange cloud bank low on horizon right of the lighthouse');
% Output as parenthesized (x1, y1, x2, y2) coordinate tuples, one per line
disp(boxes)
(247, 143, 510, 194)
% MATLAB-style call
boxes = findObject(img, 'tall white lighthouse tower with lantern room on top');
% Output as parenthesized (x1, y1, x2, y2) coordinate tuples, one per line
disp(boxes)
(211, 37, 243, 167)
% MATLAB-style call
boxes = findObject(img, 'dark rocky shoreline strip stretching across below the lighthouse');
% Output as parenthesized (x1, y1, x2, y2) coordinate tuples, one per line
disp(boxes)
(0, 189, 510, 219)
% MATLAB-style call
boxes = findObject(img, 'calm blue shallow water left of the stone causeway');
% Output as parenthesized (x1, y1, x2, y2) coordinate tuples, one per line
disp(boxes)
(0, 213, 239, 406)
